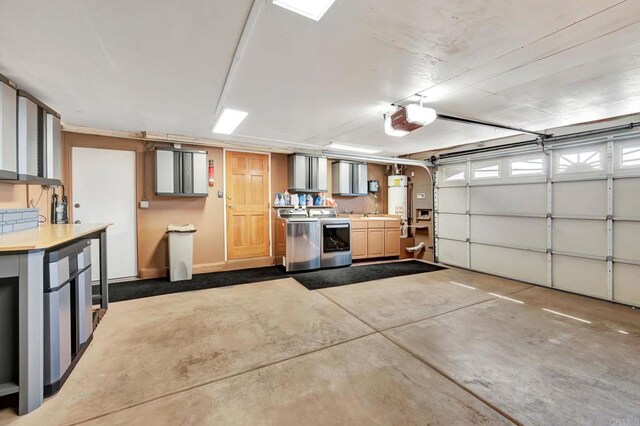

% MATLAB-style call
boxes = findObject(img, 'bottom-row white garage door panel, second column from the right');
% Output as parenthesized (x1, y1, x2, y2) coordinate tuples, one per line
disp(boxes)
(553, 255, 607, 299)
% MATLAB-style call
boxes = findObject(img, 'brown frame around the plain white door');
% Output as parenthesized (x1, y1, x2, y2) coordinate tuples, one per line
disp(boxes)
(70, 145, 139, 283)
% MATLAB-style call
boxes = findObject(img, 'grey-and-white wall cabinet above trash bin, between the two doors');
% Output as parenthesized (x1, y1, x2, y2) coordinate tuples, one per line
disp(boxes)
(156, 148, 209, 197)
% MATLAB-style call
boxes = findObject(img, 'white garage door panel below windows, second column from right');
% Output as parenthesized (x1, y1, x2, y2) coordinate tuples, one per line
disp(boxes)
(553, 180, 607, 217)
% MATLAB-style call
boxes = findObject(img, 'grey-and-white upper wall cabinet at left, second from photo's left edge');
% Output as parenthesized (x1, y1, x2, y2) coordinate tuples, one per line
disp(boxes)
(17, 90, 61, 180)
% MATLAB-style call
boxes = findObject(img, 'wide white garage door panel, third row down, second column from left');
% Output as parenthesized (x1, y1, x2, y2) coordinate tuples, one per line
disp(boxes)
(471, 216, 547, 250)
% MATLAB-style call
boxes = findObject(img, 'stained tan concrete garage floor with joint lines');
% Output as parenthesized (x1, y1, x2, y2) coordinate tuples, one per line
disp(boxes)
(0, 269, 640, 425)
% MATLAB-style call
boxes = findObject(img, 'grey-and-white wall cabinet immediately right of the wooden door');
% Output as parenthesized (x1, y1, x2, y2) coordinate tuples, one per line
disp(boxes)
(288, 154, 327, 192)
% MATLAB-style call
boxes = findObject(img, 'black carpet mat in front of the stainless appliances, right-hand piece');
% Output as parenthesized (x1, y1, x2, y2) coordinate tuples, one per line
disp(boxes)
(292, 260, 447, 290)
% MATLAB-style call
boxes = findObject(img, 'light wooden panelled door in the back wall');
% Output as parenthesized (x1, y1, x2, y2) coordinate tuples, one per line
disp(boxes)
(225, 151, 270, 260)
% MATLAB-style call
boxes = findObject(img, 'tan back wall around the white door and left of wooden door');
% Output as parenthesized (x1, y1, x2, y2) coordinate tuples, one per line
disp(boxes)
(63, 133, 287, 278)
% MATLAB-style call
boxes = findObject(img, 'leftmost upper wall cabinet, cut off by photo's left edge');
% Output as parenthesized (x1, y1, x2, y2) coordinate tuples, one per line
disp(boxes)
(0, 75, 18, 179)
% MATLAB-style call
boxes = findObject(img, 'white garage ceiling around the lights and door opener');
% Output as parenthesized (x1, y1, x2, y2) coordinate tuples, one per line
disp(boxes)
(0, 0, 640, 155)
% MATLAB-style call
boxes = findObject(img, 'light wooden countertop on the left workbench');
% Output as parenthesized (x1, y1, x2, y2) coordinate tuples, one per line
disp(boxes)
(0, 223, 112, 253)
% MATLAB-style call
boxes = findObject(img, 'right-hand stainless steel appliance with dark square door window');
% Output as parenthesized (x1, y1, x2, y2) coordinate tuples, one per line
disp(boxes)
(309, 209, 352, 268)
